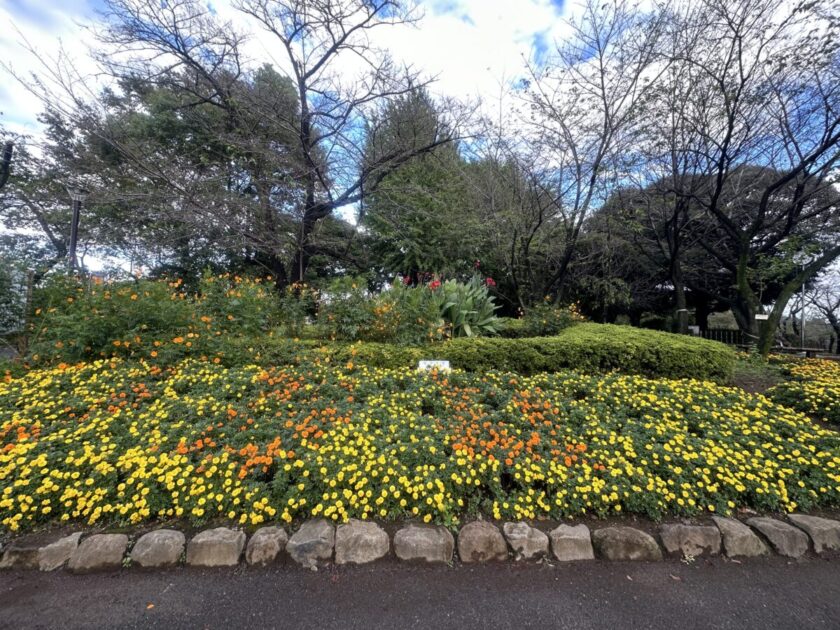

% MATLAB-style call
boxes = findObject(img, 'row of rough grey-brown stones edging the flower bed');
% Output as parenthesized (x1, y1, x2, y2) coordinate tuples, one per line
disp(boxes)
(0, 514, 840, 573)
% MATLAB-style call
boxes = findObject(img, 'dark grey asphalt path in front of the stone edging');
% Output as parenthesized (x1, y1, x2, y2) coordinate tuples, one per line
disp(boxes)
(0, 558, 840, 630)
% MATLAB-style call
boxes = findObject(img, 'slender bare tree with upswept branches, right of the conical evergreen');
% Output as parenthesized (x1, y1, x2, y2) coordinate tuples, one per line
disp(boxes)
(523, 0, 668, 297)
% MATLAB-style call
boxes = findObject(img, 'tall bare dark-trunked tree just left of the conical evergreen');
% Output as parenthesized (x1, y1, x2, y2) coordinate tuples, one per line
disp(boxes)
(237, 0, 472, 281)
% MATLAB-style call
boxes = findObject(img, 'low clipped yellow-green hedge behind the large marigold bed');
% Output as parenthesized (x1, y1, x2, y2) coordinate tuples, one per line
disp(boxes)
(246, 323, 735, 382)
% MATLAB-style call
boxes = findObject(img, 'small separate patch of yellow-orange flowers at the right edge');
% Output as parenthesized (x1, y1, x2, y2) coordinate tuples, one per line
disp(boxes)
(767, 357, 840, 424)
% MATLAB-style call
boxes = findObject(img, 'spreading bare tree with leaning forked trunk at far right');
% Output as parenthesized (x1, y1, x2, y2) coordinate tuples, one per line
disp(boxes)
(678, 0, 840, 353)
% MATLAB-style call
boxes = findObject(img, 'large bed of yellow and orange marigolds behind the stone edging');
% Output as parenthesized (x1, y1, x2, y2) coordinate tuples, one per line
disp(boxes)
(0, 359, 840, 531)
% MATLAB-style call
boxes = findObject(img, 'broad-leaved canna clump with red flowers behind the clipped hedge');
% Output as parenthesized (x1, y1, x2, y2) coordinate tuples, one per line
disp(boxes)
(430, 276, 501, 337)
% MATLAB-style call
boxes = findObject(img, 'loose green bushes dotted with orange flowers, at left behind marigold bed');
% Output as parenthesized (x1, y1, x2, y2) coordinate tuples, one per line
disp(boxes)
(29, 276, 279, 364)
